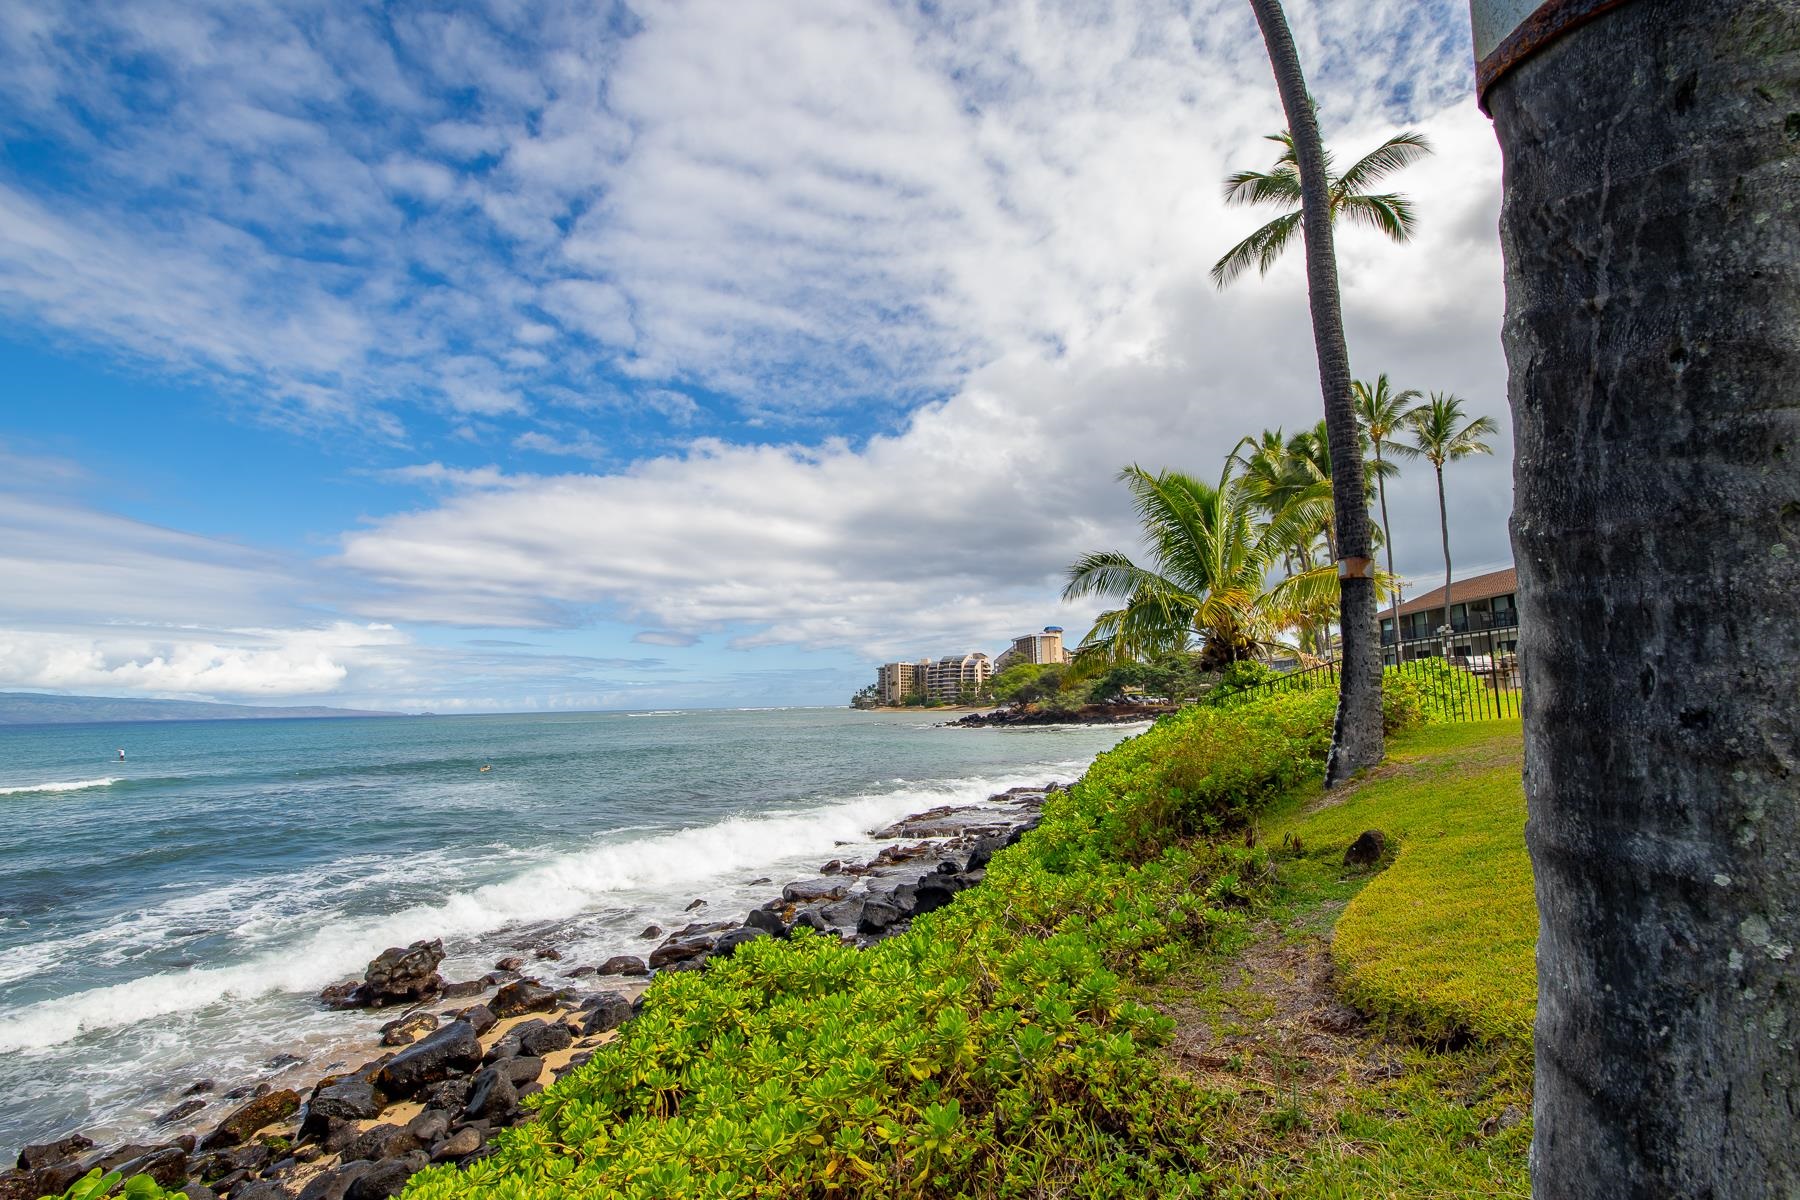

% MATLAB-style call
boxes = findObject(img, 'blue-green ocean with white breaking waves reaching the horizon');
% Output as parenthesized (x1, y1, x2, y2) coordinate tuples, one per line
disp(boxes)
(0, 709, 1134, 1157)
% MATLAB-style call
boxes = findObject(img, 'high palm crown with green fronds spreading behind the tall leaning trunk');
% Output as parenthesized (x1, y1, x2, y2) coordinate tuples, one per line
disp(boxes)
(1213, 130, 1431, 288)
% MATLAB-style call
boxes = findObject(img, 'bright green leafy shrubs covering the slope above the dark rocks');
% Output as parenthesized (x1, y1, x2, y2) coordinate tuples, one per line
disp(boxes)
(407, 693, 1418, 1200)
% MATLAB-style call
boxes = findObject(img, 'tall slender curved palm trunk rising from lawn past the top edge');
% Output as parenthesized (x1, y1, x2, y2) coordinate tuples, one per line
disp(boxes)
(1249, 0, 1384, 786)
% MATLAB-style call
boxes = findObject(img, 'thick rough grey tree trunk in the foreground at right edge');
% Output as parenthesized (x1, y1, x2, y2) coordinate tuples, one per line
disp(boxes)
(1476, 0, 1800, 1200)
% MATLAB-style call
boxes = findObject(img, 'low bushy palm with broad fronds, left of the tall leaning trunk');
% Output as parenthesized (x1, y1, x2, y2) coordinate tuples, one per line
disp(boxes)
(1062, 459, 1337, 669)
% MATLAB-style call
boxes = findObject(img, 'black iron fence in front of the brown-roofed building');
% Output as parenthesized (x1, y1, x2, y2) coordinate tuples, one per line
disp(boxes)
(1201, 626, 1519, 721)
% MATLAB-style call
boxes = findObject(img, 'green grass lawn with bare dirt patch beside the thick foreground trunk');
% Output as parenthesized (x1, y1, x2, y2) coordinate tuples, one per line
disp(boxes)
(1161, 720, 1537, 1200)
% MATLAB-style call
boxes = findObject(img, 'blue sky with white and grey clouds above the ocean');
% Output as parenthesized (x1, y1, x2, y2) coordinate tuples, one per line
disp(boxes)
(0, 0, 1512, 712)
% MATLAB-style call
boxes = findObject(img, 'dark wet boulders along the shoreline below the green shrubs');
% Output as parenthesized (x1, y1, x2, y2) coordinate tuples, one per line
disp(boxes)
(0, 788, 1051, 1200)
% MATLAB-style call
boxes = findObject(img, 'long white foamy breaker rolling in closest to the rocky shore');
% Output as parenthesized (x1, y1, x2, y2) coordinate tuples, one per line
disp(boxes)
(0, 761, 1082, 1052)
